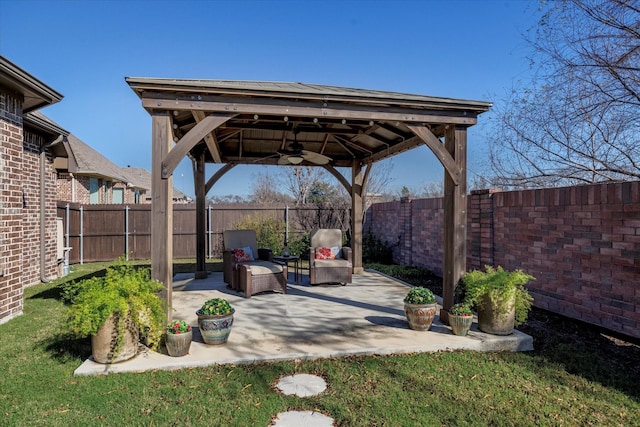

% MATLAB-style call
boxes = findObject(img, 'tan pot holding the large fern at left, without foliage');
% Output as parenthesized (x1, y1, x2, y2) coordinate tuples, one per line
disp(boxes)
(91, 316, 140, 363)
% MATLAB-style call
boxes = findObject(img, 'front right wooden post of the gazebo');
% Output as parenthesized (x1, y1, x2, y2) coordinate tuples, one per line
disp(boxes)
(440, 125, 467, 324)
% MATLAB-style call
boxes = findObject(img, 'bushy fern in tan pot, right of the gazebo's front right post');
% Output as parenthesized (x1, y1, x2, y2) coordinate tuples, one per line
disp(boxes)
(462, 265, 535, 335)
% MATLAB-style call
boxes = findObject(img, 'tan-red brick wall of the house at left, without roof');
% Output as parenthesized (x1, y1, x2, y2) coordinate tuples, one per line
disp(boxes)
(0, 87, 58, 323)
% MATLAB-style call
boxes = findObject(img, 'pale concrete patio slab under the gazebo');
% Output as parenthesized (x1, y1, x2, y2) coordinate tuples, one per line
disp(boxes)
(74, 271, 533, 375)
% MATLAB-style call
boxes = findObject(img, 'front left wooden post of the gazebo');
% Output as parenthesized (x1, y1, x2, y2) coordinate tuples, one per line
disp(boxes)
(151, 111, 173, 321)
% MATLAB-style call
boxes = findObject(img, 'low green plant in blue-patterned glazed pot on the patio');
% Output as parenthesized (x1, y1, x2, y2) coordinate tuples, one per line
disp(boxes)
(196, 298, 235, 344)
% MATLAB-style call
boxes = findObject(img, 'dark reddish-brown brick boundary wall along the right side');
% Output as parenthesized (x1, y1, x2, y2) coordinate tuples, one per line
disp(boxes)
(365, 182, 640, 337)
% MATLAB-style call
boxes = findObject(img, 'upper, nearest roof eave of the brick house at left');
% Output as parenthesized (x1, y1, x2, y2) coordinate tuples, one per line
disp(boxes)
(0, 56, 63, 113)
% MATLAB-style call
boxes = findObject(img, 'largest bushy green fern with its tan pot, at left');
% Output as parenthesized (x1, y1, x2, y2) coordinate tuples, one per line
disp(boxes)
(65, 257, 166, 363)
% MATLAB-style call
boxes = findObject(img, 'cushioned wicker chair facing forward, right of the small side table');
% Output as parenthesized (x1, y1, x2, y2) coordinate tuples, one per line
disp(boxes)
(309, 228, 353, 285)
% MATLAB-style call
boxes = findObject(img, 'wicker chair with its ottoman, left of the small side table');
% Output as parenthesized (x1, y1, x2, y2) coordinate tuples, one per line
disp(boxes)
(222, 230, 287, 298)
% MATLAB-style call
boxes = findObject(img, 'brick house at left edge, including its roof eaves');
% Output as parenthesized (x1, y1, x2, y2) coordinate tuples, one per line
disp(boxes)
(0, 56, 68, 323)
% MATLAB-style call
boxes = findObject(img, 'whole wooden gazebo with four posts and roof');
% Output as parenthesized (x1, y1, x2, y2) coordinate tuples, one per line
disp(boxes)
(126, 77, 491, 321)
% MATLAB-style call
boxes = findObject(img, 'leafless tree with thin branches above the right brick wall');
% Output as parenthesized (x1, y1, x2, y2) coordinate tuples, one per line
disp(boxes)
(490, 0, 640, 188)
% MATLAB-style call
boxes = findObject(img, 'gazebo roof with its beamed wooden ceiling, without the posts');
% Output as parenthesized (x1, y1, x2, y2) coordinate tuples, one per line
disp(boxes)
(126, 77, 491, 167)
